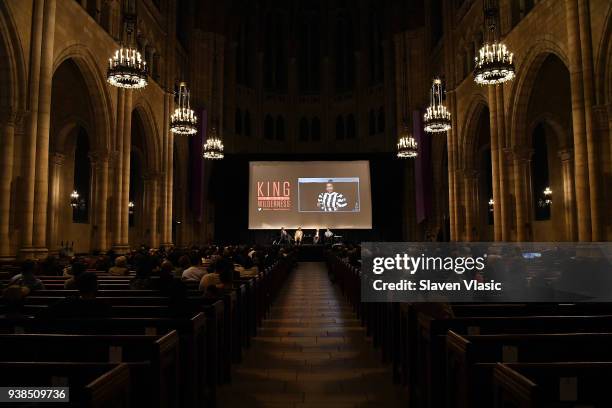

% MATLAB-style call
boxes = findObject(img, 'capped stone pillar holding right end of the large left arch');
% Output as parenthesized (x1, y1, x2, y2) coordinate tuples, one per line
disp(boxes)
(90, 150, 110, 251)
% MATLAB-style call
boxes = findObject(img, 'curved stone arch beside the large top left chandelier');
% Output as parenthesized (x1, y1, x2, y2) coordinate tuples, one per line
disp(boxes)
(53, 44, 115, 151)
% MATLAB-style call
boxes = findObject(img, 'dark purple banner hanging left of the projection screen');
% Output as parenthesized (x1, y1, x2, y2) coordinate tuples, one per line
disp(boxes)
(189, 109, 208, 222)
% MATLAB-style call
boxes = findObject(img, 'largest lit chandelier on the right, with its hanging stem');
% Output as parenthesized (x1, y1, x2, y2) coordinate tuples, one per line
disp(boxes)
(474, 0, 515, 85)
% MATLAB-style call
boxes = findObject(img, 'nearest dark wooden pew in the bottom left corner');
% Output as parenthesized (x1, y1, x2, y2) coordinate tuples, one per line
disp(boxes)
(0, 362, 134, 408)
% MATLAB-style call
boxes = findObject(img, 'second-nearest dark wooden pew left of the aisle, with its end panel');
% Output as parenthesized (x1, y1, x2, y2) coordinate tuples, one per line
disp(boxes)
(0, 331, 179, 408)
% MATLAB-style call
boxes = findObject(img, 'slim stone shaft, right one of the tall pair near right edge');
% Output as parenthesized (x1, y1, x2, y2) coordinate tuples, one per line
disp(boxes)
(578, 0, 605, 241)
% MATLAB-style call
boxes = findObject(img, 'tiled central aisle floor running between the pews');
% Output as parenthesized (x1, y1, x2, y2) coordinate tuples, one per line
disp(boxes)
(219, 262, 408, 408)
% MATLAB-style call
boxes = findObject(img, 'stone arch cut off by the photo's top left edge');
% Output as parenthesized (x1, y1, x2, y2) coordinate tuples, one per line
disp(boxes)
(0, 2, 27, 111)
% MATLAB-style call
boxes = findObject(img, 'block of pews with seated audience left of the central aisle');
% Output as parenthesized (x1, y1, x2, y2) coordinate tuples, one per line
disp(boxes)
(0, 247, 295, 407)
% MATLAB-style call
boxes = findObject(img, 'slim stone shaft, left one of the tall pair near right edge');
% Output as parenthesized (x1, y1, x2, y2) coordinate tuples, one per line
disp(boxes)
(565, 0, 592, 241)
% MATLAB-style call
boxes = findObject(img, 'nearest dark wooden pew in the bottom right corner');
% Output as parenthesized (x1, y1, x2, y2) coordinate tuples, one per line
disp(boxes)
(492, 362, 612, 408)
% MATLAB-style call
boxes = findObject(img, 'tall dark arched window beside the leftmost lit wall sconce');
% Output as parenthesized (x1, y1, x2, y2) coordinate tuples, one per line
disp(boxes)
(71, 128, 91, 224)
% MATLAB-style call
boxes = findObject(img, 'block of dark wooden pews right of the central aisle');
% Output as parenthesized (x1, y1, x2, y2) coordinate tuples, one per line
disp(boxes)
(327, 247, 612, 408)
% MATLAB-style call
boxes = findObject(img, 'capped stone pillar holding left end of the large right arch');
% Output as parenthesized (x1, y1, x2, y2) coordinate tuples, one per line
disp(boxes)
(511, 147, 533, 242)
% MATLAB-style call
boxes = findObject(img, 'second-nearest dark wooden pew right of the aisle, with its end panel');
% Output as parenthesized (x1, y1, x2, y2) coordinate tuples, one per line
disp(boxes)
(446, 331, 612, 408)
